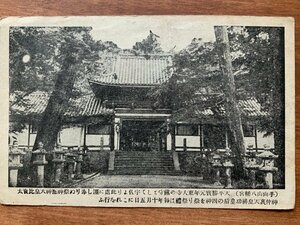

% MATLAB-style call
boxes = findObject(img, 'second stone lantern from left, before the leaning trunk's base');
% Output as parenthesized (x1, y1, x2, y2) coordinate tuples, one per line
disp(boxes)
(32, 142, 48, 187)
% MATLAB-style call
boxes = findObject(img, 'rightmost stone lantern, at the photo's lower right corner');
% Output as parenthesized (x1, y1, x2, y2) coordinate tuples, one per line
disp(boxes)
(257, 147, 278, 188)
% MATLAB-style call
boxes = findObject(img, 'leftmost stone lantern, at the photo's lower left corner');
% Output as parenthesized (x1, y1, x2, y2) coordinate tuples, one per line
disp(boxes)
(8, 143, 25, 187)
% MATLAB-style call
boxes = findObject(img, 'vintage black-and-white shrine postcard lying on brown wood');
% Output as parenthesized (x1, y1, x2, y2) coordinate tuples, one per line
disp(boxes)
(0, 16, 295, 209)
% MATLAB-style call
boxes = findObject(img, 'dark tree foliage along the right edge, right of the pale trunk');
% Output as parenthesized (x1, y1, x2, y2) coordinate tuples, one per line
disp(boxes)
(229, 27, 285, 183)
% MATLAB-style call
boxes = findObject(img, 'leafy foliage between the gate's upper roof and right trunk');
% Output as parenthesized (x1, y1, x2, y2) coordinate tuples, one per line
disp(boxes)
(151, 38, 223, 120)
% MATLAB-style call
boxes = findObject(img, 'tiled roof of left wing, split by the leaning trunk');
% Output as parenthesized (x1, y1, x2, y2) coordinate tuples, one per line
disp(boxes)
(11, 92, 113, 117)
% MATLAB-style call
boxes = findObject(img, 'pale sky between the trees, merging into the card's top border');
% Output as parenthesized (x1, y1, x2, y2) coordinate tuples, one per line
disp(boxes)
(92, 17, 215, 51)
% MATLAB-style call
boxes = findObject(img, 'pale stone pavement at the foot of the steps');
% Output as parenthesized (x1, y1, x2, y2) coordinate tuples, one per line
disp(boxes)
(72, 174, 223, 188)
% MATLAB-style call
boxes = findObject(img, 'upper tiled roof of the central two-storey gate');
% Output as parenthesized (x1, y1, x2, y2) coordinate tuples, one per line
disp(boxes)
(90, 54, 171, 86)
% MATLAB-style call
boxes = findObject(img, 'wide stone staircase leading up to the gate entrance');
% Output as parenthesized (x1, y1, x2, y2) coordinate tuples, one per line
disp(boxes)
(108, 151, 181, 176)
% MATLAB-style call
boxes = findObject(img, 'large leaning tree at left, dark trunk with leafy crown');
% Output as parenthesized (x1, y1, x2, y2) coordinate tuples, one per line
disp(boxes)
(10, 27, 99, 151)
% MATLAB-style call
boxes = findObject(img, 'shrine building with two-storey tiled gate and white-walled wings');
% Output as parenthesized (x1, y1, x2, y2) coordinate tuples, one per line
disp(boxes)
(10, 54, 274, 174)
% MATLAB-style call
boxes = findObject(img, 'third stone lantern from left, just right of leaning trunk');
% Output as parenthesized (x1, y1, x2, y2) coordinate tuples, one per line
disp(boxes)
(52, 144, 65, 187)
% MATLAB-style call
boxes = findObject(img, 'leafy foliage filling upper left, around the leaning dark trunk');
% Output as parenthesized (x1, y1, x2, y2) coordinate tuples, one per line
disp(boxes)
(9, 27, 119, 131)
